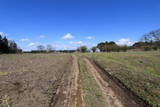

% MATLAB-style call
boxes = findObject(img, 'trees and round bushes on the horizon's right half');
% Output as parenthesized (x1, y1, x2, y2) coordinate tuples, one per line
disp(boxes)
(77, 29, 160, 52)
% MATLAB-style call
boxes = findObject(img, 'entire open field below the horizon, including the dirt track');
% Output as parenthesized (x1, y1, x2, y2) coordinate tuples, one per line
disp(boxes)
(0, 51, 160, 107)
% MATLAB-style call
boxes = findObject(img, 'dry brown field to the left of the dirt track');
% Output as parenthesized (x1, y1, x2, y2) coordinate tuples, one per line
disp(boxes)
(0, 54, 75, 107)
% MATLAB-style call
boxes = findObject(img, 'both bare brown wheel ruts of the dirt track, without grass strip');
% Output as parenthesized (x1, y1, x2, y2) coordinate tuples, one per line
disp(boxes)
(56, 55, 144, 107)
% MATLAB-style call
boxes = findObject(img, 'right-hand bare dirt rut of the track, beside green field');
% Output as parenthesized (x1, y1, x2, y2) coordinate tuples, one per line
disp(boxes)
(84, 58, 144, 107)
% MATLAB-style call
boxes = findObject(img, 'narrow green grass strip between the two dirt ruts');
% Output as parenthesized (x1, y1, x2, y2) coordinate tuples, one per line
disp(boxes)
(79, 59, 107, 107)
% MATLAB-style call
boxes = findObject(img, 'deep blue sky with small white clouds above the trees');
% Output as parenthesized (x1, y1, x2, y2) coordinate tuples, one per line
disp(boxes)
(0, 0, 160, 50)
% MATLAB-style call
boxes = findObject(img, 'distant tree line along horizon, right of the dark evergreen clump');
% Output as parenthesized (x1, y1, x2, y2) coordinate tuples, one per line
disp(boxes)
(32, 29, 160, 53)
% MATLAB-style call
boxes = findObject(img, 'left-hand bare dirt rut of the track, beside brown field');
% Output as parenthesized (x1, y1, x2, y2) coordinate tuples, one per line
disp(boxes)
(49, 55, 84, 107)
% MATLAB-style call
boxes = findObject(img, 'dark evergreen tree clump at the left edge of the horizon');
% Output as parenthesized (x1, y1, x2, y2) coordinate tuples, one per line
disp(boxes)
(0, 35, 22, 53)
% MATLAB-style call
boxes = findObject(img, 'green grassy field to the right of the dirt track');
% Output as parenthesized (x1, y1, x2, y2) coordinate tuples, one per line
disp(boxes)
(83, 51, 160, 106)
